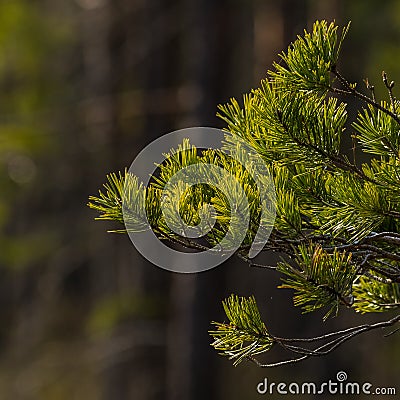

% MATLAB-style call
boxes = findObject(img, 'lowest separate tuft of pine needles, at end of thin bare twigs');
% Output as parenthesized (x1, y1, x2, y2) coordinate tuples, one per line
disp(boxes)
(209, 295, 274, 366)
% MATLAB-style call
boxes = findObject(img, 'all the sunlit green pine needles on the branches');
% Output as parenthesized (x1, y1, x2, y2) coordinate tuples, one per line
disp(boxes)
(90, 21, 400, 365)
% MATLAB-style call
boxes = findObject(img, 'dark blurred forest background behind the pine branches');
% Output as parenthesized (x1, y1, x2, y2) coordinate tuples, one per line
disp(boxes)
(0, 0, 400, 400)
